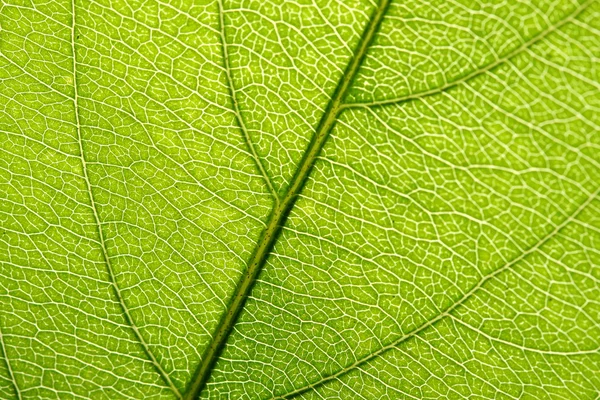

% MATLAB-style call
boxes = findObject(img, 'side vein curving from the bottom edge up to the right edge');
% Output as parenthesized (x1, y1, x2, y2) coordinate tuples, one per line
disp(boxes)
(271, 187, 600, 400)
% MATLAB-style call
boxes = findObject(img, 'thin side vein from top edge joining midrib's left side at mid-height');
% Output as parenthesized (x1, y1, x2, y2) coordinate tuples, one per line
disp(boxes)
(217, 0, 279, 206)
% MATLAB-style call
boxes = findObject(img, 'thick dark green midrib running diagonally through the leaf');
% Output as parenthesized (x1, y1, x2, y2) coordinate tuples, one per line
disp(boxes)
(184, 0, 390, 400)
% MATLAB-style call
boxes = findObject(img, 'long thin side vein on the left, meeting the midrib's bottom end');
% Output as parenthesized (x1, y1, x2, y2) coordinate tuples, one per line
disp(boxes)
(71, 0, 181, 398)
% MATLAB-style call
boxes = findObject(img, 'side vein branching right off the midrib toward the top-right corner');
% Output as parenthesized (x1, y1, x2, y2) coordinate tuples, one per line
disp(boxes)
(342, 0, 596, 109)
